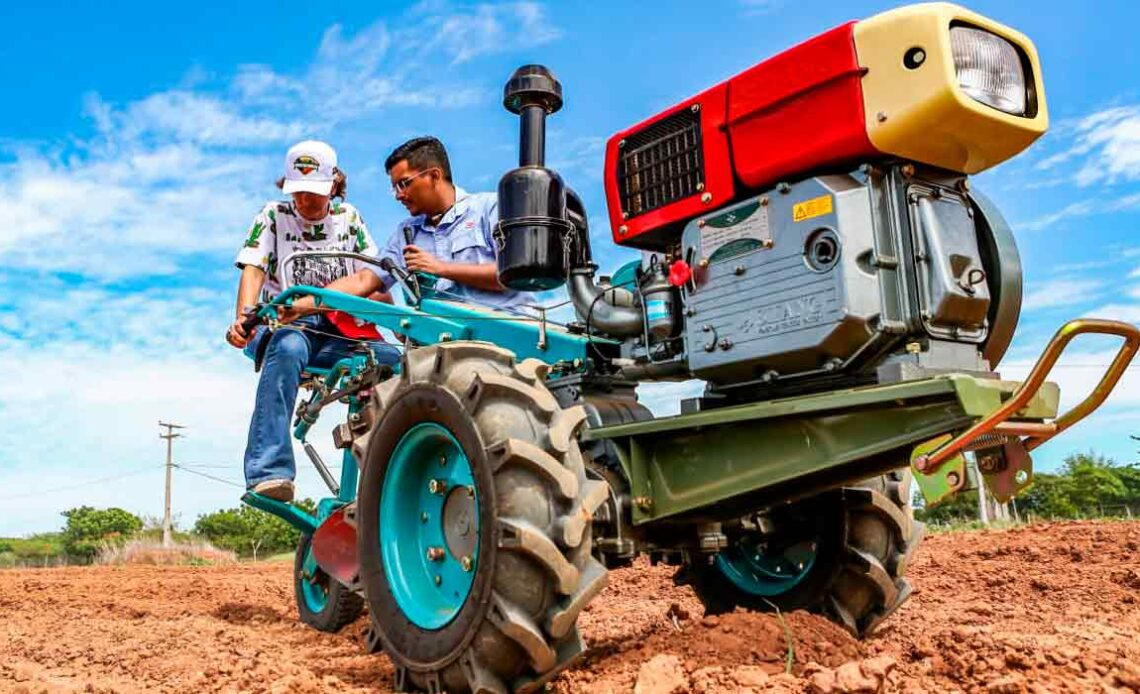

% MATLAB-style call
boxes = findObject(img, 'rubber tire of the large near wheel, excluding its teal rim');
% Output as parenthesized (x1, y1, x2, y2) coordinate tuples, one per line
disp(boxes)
(355, 342, 608, 694)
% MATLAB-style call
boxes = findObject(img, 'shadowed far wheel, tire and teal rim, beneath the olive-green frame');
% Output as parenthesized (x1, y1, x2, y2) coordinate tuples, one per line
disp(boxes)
(676, 471, 925, 638)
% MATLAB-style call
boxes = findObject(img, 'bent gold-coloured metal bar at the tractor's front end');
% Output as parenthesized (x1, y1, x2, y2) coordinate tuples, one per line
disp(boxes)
(914, 318, 1140, 472)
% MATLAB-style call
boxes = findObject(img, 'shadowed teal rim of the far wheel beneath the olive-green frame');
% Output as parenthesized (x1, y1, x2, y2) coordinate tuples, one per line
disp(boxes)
(716, 538, 816, 597)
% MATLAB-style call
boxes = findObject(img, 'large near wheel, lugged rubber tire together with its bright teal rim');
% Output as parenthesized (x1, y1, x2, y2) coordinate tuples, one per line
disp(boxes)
(355, 342, 608, 694)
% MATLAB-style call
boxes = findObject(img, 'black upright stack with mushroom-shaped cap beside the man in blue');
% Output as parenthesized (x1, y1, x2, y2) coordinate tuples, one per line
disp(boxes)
(495, 65, 573, 291)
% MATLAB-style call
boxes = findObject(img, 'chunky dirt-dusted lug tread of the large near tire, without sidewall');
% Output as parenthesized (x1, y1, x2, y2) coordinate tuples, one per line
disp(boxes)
(364, 342, 609, 694)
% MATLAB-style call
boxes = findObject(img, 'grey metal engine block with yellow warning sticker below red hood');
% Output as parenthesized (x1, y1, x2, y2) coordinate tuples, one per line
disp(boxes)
(681, 165, 992, 385)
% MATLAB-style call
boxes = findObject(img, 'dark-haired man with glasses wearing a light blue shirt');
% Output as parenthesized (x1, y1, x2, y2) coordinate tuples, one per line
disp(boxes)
(380, 137, 534, 308)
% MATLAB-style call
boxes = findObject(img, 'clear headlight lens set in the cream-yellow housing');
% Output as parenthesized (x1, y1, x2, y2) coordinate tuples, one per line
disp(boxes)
(950, 26, 1026, 115)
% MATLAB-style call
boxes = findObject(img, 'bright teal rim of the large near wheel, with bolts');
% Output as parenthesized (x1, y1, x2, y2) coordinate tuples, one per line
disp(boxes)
(378, 422, 479, 629)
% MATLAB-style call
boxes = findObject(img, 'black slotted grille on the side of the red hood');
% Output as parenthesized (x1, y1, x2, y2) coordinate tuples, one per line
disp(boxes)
(618, 109, 705, 217)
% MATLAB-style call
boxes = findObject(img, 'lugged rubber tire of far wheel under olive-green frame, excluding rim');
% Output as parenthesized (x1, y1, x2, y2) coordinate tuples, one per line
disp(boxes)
(677, 471, 925, 637)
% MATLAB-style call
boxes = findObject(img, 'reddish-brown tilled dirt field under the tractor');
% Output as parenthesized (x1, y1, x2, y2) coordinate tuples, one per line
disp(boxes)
(0, 522, 1140, 694)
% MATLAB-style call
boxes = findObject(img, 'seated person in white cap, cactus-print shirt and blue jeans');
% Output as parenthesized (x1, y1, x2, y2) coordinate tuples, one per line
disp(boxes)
(226, 140, 399, 501)
